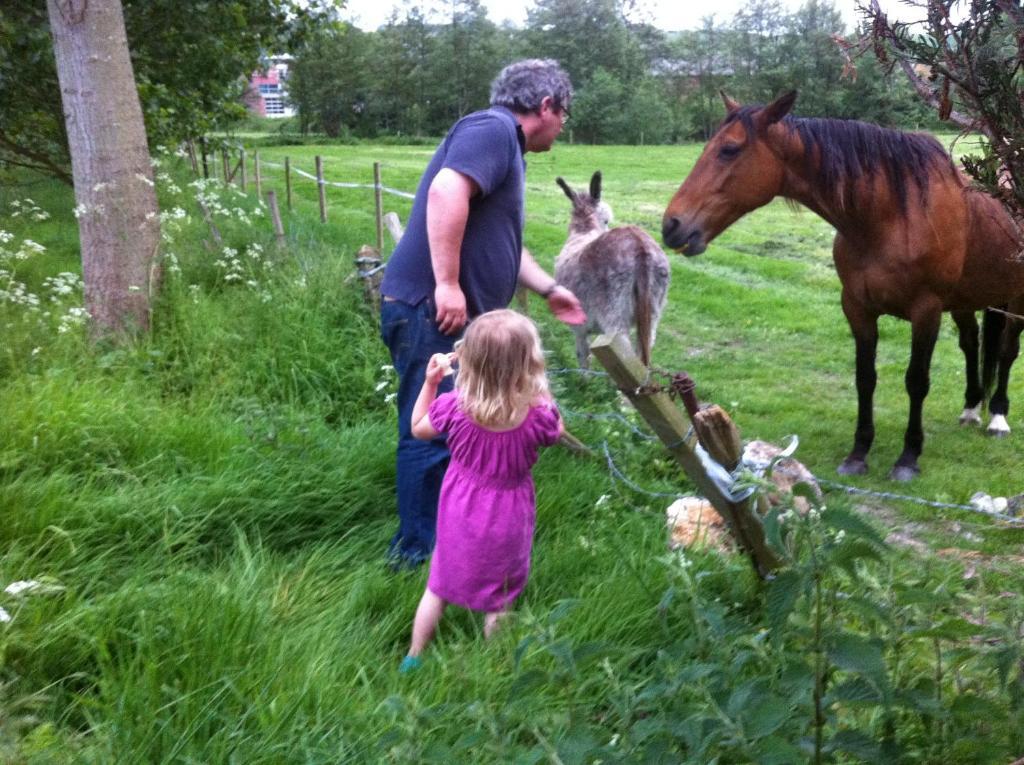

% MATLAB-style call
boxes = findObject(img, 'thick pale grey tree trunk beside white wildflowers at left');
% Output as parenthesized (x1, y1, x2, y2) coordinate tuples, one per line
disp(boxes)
(46, 0, 160, 339)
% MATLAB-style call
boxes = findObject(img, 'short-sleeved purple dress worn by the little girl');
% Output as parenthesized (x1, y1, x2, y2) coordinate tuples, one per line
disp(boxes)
(427, 391, 560, 611)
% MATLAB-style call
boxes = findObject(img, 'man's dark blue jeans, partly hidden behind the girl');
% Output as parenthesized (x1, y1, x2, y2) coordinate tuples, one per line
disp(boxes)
(381, 298, 459, 565)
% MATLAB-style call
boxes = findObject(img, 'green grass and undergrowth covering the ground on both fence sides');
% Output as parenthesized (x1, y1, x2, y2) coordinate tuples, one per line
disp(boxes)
(0, 139, 1024, 763)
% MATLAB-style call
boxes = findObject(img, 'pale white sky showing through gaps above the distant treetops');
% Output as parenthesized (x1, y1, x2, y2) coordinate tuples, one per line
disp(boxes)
(343, 0, 921, 31)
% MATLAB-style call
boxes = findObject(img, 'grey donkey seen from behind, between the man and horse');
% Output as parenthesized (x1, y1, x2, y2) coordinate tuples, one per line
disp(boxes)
(555, 171, 669, 369)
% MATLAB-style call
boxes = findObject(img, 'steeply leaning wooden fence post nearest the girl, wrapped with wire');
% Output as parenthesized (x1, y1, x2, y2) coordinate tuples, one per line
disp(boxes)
(590, 335, 780, 579)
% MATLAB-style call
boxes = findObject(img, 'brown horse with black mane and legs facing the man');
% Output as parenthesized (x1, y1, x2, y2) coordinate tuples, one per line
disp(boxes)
(662, 92, 1024, 480)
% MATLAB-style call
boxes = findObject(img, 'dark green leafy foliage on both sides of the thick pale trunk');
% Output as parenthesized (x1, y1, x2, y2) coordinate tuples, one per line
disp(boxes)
(0, 0, 335, 183)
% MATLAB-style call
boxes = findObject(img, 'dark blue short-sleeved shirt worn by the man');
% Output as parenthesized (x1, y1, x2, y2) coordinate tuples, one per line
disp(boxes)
(381, 107, 526, 317)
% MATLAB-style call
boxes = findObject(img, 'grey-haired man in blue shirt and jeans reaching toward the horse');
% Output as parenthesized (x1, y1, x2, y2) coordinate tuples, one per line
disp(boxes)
(381, 59, 586, 565)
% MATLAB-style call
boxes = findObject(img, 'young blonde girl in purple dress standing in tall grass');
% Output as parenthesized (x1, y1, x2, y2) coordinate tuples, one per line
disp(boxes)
(401, 310, 562, 672)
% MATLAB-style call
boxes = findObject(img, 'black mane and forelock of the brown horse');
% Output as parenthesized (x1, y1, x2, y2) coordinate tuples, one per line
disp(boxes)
(722, 105, 952, 213)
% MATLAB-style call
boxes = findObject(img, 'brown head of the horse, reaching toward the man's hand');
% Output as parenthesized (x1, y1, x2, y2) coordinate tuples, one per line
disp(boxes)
(662, 91, 797, 255)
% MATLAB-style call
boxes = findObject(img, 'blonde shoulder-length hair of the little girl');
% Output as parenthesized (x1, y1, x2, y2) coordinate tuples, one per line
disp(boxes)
(455, 309, 551, 428)
